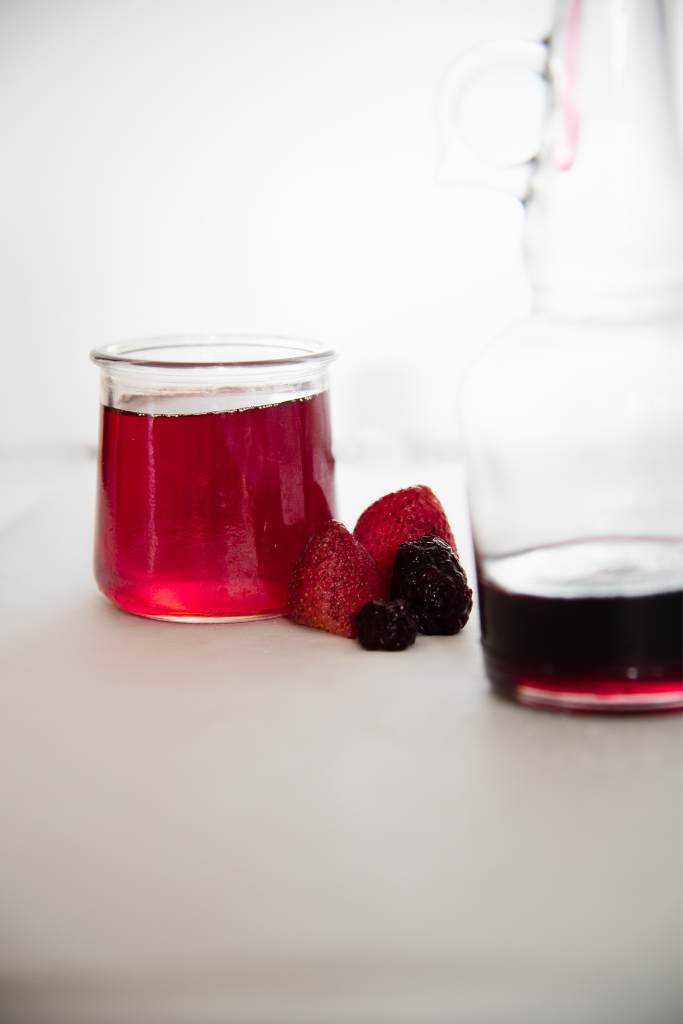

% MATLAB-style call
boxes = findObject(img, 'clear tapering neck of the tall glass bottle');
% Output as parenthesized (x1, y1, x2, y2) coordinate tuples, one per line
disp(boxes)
(524, 0, 683, 315)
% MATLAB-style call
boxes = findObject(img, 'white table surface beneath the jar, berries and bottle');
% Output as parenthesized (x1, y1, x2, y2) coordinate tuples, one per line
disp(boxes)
(0, 450, 683, 1024)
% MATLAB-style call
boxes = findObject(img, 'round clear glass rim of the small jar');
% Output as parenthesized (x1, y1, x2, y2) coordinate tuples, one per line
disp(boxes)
(90, 333, 337, 370)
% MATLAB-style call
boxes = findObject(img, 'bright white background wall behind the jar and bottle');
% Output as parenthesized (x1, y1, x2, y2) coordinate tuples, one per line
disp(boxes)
(0, 0, 552, 458)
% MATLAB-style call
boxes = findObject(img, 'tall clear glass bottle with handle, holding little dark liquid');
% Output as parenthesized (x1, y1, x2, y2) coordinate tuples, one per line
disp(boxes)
(441, 0, 683, 712)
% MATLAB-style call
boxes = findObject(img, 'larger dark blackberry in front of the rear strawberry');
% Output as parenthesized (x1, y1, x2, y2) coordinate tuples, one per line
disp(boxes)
(391, 535, 472, 636)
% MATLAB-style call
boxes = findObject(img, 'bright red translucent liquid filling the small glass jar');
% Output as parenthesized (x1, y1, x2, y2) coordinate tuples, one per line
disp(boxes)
(95, 392, 335, 620)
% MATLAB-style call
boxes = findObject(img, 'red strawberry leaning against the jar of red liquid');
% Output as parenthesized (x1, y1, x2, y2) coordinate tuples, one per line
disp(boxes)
(289, 519, 387, 637)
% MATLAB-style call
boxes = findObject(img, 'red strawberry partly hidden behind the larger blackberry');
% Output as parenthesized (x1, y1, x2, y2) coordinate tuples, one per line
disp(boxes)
(353, 483, 457, 580)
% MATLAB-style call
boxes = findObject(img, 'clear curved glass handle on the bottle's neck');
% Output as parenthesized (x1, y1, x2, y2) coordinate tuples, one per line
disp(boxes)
(436, 40, 548, 200)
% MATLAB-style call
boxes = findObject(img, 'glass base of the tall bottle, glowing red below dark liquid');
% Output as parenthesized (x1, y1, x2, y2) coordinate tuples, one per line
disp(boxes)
(484, 651, 683, 715)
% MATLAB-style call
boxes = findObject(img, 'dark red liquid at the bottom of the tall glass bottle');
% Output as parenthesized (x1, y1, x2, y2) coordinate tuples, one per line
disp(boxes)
(479, 579, 683, 711)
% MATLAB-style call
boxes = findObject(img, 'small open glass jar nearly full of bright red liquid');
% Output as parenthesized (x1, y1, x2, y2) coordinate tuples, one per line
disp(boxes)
(91, 336, 335, 623)
